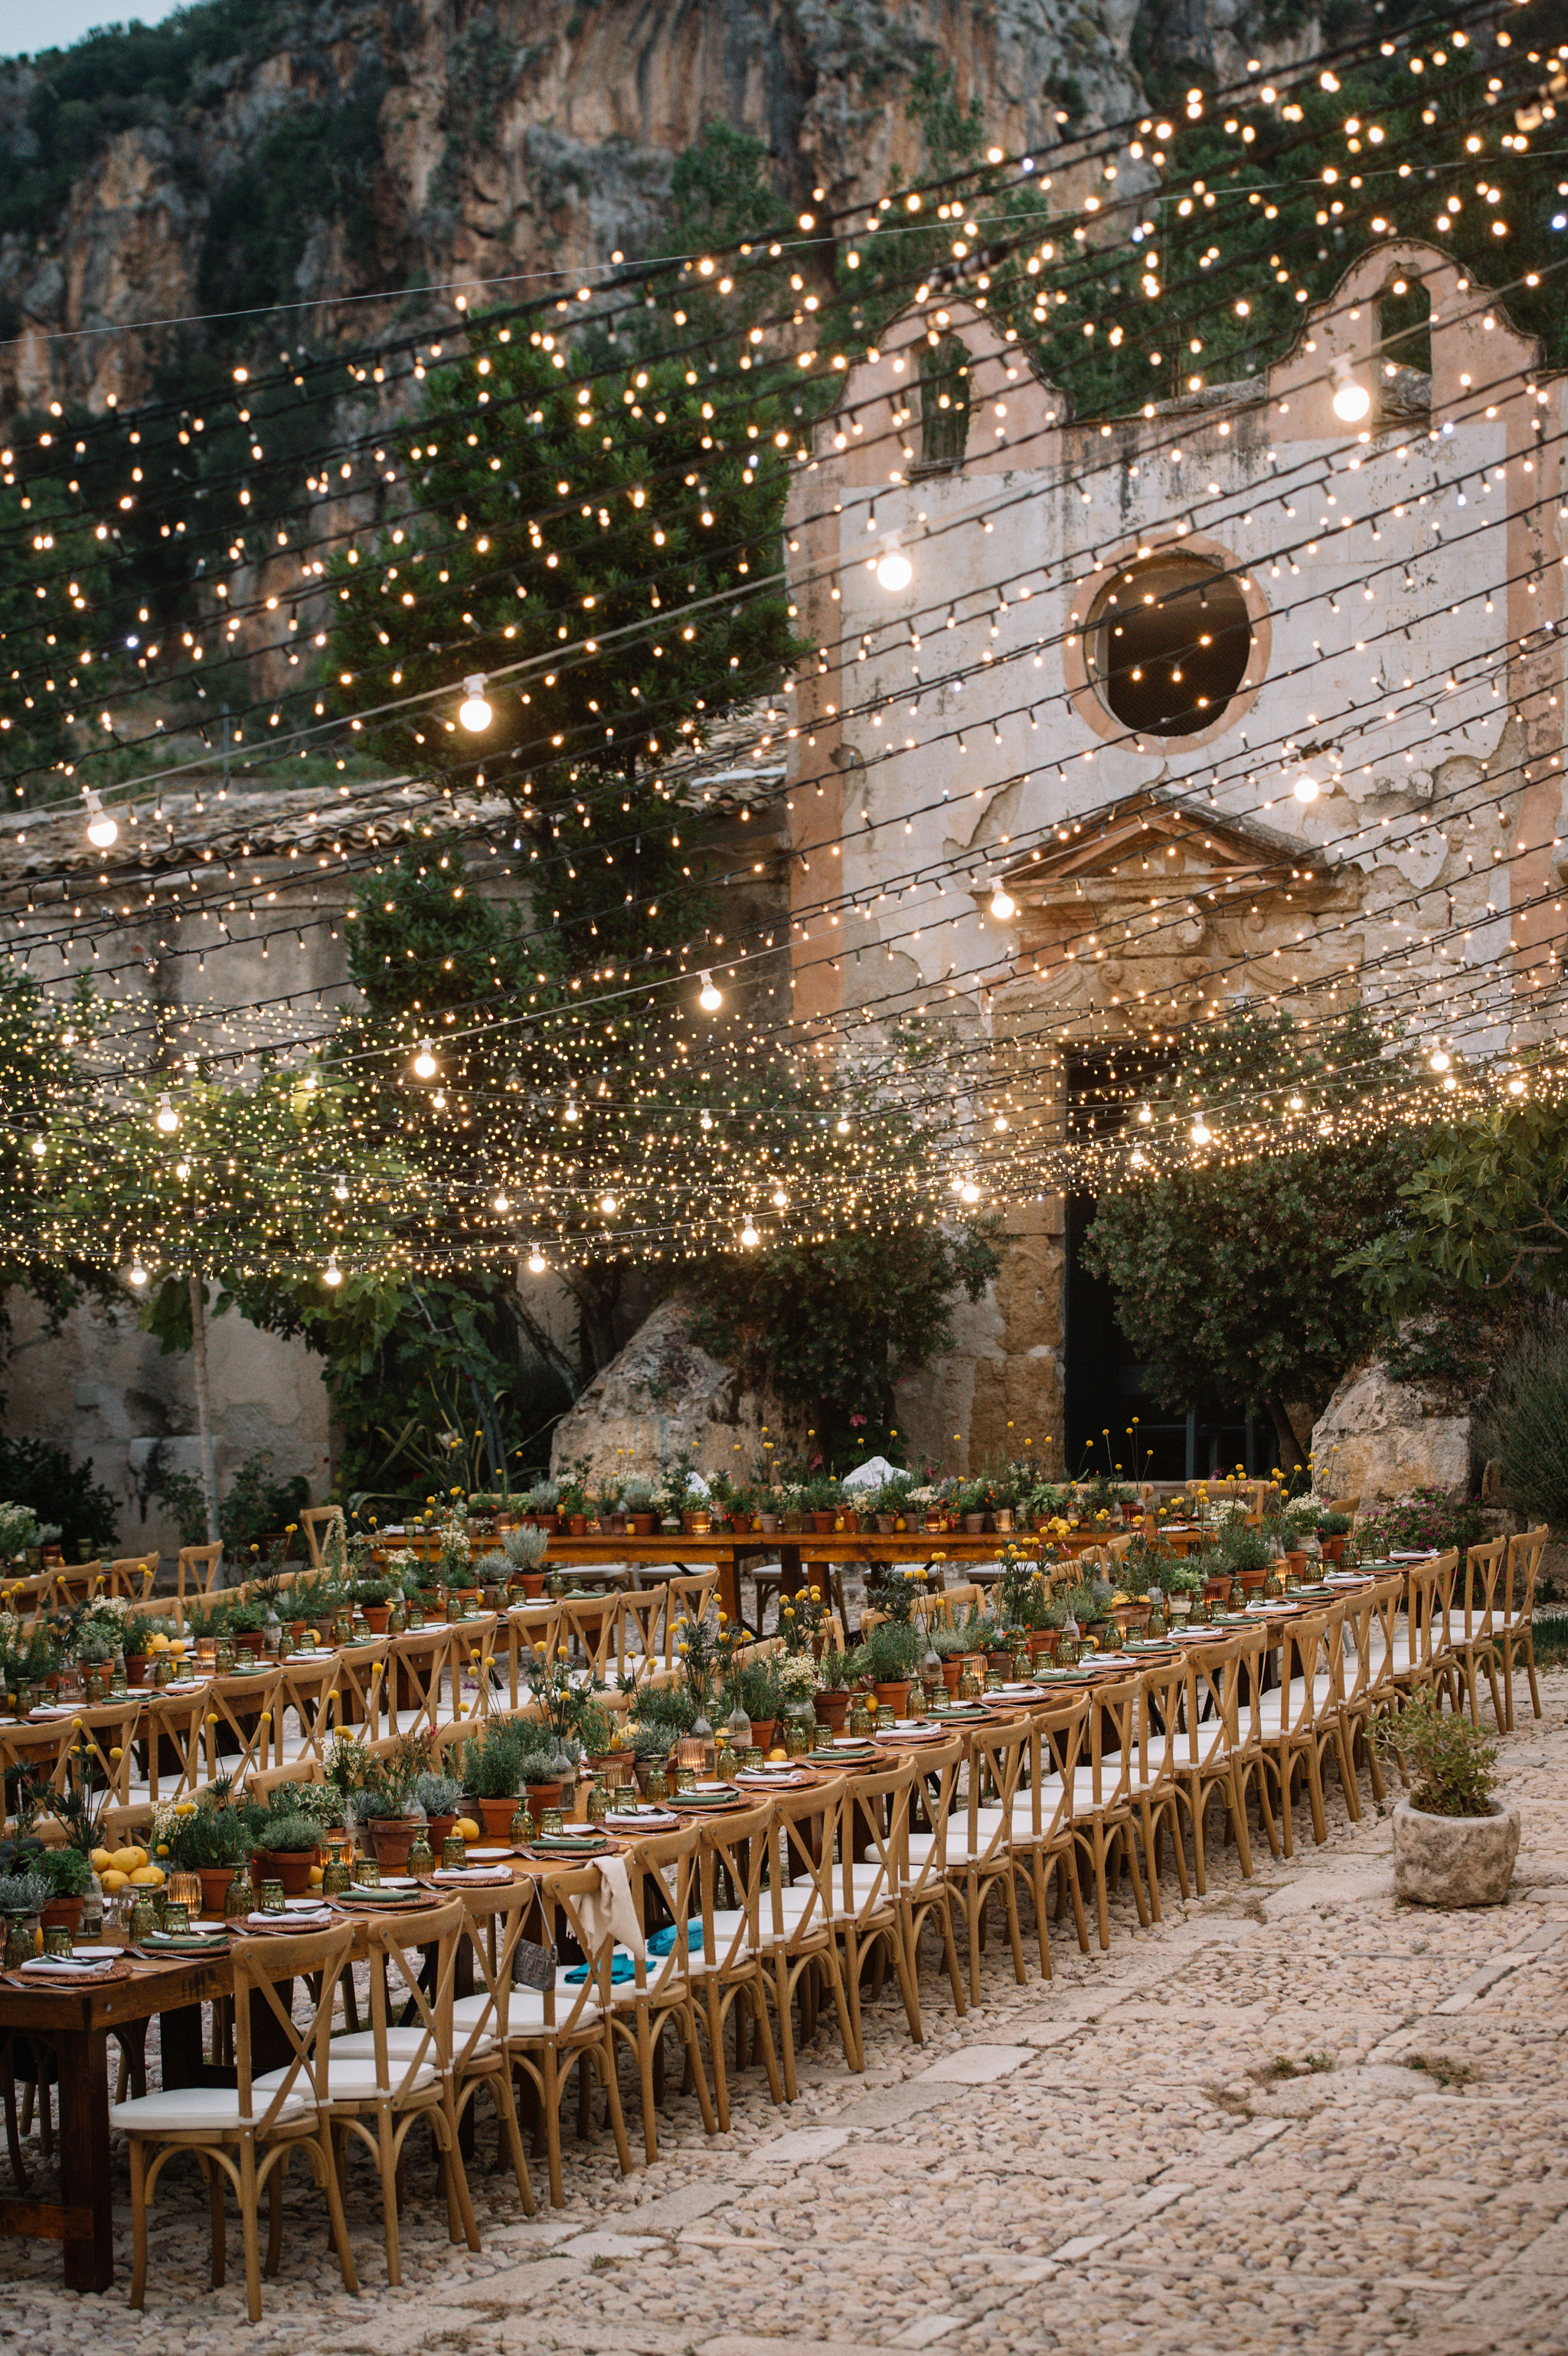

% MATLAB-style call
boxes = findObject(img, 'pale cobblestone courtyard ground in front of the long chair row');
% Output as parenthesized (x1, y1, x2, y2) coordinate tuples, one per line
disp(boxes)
(0, 1673, 1568, 2356)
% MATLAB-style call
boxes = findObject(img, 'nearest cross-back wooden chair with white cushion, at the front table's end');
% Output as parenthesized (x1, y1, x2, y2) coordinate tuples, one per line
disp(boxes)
(108, 1923, 360, 2323)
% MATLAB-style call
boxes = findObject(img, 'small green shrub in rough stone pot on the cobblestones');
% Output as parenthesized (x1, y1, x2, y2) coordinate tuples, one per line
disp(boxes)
(1377, 1694, 1518, 1906)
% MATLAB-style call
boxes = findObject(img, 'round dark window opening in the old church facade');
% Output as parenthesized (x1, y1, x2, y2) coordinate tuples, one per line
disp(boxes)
(1083, 551, 1253, 735)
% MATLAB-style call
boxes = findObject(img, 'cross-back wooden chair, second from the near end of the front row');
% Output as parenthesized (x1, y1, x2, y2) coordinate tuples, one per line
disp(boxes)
(310, 1897, 480, 2283)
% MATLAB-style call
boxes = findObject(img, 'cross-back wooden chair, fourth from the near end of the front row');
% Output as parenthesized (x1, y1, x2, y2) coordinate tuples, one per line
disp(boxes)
(506, 1866, 635, 2207)
